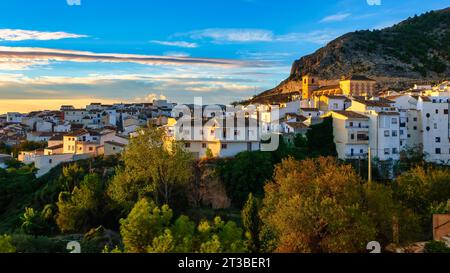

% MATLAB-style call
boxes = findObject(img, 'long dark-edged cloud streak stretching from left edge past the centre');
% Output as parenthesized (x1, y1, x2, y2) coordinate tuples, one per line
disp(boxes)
(0, 46, 253, 70)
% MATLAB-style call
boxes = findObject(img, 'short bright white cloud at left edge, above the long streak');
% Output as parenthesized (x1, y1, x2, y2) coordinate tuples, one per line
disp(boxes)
(0, 29, 88, 42)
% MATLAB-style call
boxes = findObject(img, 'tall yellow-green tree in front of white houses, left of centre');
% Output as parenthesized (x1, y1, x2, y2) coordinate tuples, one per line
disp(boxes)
(109, 128, 193, 209)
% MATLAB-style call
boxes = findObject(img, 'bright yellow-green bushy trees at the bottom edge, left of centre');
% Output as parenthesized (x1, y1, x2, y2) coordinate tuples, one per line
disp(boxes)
(120, 199, 247, 253)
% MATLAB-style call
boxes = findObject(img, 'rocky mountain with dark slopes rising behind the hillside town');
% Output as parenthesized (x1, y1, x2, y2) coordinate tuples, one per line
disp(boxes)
(253, 8, 450, 101)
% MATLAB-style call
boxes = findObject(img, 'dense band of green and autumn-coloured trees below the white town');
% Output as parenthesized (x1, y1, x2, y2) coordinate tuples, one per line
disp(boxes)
(0, 120, 450, 253)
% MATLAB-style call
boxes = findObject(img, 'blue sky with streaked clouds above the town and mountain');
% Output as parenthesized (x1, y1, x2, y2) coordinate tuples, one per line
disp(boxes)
(0, 0, 450, 113)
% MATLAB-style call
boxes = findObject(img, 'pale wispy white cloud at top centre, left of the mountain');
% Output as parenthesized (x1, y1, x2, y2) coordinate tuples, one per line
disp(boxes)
(175, 28, 274, 43)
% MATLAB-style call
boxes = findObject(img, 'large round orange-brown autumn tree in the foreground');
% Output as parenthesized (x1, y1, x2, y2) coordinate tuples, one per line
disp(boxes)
(260, 157, 376, 252)
